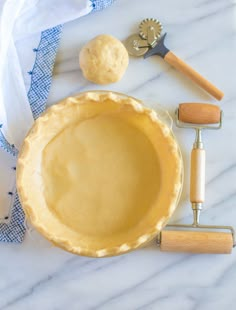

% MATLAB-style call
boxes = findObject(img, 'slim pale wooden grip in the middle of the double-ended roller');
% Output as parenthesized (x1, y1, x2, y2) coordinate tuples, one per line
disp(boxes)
(190, 149, 206, 203)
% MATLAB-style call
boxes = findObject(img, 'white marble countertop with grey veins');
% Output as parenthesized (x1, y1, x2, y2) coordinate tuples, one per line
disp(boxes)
(0, 0, 236, 310)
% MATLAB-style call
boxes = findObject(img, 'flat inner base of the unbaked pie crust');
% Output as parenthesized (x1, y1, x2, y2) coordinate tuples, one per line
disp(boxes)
(42, 115, 160, 238)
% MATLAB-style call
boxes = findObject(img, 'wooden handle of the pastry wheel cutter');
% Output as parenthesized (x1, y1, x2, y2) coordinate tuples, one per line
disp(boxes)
(164, 51, 224, 100)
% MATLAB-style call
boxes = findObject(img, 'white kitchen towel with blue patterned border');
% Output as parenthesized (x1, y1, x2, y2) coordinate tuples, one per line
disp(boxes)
(0, 0, 113, 242)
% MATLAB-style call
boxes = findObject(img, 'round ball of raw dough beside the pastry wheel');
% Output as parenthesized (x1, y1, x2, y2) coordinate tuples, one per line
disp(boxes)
(79, 34, 129, 84)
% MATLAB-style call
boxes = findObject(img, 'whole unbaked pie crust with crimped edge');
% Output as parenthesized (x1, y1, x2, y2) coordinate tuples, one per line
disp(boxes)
(17, 92, 182, 257)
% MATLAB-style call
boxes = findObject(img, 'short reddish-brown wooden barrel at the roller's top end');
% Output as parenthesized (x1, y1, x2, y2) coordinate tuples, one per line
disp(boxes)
(178, 102, 221, 124)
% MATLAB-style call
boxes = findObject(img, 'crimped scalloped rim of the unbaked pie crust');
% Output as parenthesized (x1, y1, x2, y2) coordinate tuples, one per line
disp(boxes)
(17, 91, 183, 257)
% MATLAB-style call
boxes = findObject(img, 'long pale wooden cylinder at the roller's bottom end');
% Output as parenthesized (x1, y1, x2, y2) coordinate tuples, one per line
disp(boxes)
(160, 230, 233, 254)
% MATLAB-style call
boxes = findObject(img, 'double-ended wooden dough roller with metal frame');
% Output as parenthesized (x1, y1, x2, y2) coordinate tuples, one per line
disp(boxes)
(158, 103, 235, 254)
